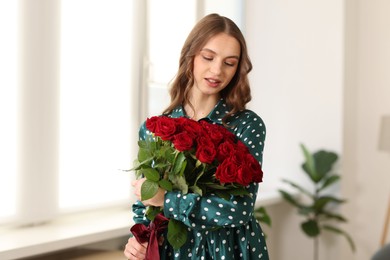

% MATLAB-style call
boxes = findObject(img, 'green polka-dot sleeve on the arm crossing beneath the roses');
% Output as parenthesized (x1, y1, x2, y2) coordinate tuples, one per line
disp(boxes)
(164, 111, 265, 229)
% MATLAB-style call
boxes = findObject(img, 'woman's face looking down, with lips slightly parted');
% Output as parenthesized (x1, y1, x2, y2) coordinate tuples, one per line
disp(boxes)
(192, 33, 240, 97)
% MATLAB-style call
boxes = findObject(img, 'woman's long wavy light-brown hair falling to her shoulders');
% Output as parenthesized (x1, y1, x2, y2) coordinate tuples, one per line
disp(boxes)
(163, 11, 252, 123)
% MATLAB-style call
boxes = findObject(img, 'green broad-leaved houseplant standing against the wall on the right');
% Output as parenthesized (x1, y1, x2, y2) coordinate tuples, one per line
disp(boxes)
(279, 144, 355, 260)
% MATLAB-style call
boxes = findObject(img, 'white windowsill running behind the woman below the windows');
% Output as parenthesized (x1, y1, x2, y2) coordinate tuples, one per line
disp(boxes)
(0, 186, 282, 259)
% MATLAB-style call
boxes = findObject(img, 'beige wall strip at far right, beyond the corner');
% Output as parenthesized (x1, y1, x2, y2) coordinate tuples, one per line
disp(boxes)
(341, 0, 390, 260)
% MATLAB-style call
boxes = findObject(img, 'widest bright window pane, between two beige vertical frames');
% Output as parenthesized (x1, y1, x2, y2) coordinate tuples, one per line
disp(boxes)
(59, 0, 137, 209)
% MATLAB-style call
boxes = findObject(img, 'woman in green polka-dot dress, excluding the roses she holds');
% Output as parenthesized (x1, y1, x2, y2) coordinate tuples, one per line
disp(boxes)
(124, 14, 268, 259)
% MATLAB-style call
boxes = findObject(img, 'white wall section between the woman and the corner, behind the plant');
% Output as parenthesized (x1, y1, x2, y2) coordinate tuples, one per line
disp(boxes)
(245, 0, 348, 260)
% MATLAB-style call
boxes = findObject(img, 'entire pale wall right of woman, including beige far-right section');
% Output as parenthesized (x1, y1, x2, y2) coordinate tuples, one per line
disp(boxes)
(246, 0, 390, 260)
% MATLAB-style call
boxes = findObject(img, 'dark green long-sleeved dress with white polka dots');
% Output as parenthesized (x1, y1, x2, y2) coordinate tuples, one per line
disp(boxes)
(133, 99, 269, 260)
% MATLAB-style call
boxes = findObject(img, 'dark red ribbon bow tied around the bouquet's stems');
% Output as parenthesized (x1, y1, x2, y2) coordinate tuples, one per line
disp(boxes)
(130, 214, 169, 260)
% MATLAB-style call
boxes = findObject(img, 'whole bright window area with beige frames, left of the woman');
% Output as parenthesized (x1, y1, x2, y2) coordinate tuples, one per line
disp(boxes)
(0, 0, 244, 224)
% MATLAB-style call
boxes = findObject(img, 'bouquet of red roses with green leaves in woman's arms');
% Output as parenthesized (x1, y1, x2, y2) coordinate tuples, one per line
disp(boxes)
(133, 116, 263, 252)
